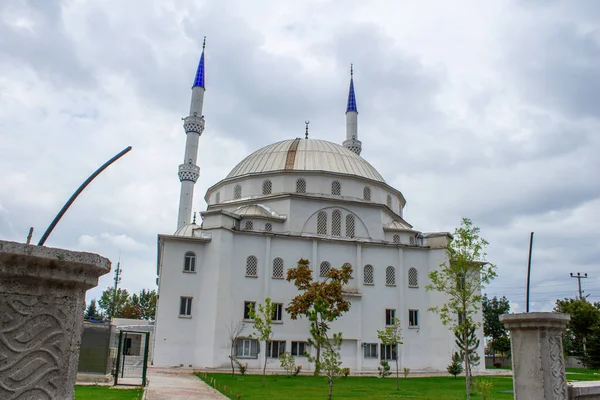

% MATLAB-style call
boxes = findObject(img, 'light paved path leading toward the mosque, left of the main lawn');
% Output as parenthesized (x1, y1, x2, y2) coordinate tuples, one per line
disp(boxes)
(145, 371, 227, 400)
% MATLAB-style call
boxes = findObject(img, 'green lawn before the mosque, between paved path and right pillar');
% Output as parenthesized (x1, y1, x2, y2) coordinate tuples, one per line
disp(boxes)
(198, 374, 513, 400)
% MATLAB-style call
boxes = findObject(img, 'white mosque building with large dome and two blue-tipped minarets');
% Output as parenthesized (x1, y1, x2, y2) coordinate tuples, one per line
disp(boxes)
(153, 43, 482, 372)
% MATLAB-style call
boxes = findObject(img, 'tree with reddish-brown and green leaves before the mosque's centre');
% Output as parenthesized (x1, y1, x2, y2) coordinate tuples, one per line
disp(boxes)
(285, 259, 352, 375)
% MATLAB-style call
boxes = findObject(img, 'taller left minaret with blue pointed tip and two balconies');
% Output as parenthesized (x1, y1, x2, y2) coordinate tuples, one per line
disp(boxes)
(177, 37, 206, 229)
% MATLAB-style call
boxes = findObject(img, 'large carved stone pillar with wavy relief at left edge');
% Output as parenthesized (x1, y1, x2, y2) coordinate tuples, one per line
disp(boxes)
(0, 240, 110, 400)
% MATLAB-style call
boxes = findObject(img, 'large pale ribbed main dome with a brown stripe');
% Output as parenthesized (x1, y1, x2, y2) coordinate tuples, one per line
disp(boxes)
(227, 139, 385, 182)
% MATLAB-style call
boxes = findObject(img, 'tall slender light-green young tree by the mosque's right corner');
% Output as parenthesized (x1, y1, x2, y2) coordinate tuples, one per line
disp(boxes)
(425, 218, 496, 400)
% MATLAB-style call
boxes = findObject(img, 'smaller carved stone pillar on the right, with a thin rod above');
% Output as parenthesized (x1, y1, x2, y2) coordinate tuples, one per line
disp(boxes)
(500, 312, 570, 400)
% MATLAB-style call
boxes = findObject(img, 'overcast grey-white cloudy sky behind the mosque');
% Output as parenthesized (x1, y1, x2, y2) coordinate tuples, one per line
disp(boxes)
(0, 0, 600, 311)
